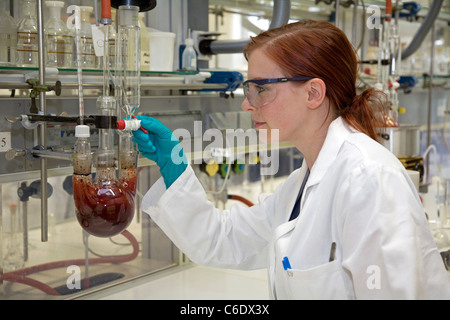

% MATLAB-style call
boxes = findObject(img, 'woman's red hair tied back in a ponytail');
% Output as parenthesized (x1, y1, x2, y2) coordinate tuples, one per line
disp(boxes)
(244, 20, 385, 140)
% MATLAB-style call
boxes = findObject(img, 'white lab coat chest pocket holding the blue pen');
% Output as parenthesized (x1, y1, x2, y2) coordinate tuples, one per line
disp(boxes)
(286, 261, 348, 300)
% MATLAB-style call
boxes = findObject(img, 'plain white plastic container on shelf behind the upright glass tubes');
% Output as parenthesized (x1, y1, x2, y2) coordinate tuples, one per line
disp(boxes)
(149, 32, 176, 71)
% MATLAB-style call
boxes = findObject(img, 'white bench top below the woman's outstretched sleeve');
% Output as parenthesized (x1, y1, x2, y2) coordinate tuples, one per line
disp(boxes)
(81, 264, 269, 300)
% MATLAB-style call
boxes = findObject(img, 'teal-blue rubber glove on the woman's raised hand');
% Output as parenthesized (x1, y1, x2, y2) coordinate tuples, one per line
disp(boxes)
(133, 116, 188, 189)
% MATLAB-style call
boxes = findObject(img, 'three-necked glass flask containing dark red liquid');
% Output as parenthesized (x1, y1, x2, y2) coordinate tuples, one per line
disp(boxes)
(73, 122, 137, 237)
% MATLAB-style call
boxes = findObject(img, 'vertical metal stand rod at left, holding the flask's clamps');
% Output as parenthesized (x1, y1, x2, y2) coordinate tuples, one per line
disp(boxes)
(36, 0, 48, 242)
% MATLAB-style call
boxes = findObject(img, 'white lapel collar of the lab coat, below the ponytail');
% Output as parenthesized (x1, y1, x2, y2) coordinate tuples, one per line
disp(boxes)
(302, 117, 356, 188)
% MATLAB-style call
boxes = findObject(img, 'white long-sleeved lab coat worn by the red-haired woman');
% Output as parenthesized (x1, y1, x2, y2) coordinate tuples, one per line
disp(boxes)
(142, 118, 450, 299)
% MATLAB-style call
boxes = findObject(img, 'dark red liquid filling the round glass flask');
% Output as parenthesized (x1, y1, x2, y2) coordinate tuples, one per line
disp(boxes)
(73, 169, 137, 237)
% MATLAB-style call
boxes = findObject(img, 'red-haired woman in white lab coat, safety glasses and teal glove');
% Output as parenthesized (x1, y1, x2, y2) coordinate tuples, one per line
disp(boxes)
(134, 21, 450, 299)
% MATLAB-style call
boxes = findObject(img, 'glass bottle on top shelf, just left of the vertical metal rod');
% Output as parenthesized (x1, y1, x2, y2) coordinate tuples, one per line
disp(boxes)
(16, 0, 39, 67)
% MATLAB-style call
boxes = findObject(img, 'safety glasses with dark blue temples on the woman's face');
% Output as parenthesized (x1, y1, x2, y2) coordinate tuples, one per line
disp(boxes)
(242, 77, 313, 108)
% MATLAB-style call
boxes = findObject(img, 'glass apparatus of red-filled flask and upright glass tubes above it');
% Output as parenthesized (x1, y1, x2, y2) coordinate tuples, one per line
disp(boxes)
(73, 6, 140, 237)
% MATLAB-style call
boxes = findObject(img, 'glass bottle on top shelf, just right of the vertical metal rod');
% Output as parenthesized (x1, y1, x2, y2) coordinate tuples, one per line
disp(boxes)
(44, 1, 74, 68)
